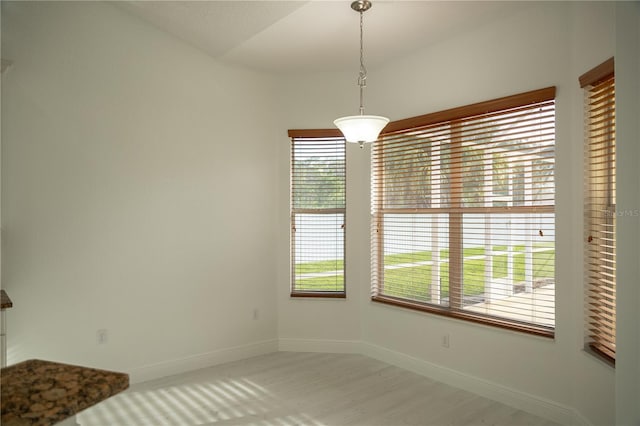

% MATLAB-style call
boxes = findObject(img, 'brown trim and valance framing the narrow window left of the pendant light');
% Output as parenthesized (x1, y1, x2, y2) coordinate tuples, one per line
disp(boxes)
(287, 129, 347, 299)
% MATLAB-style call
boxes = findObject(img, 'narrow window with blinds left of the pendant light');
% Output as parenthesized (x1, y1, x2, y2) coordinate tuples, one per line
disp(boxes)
(289, 130, 346, 297)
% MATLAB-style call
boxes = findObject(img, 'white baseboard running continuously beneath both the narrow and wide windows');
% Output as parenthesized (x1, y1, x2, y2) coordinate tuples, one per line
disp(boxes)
(278, 338, 591, 426)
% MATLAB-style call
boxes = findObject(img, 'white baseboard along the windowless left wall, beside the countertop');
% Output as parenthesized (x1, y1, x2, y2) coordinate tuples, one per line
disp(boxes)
(129, 339, 278, 384)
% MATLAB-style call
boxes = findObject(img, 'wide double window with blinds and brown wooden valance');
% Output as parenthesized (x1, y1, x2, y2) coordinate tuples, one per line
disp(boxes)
(372, 87, 555, 337)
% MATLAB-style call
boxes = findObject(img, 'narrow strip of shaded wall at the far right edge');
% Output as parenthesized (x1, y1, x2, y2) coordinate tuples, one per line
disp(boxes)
(615, 2, 640, 426)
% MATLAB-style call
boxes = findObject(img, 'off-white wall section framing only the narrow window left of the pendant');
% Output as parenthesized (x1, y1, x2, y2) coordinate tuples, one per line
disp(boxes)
(277, 73, 369, 351)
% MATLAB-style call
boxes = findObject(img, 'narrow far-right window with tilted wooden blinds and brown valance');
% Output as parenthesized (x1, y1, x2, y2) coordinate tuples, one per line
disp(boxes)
(580, 58, 616, 362)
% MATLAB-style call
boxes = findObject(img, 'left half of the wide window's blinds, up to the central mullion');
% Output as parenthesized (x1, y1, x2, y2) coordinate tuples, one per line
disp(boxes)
(372, 124, 450, 303)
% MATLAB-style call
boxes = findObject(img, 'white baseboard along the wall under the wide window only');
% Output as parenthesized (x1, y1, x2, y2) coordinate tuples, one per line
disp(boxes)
(360, 342, 589, 426)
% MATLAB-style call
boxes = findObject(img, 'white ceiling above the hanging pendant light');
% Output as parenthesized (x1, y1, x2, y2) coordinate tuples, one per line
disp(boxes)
(116, 0, 530, 73)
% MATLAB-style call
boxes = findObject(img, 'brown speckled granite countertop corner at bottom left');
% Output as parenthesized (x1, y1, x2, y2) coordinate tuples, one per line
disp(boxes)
(1, 359, 129, 426)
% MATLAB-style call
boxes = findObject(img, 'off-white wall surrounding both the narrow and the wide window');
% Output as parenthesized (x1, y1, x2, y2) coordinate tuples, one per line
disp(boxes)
(278, 2, 615, 424)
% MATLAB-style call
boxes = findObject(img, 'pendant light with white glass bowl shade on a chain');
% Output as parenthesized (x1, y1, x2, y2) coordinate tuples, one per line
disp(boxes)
(333, 0, 389, 148)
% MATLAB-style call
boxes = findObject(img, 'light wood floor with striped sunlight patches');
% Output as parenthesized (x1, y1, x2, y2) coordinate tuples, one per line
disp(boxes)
(77, 352, 556, 426)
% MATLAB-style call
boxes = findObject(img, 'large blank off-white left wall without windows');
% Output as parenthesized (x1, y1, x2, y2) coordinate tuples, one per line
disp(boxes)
(2, 2, 277, 381)
